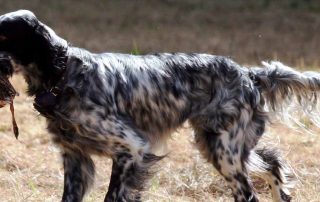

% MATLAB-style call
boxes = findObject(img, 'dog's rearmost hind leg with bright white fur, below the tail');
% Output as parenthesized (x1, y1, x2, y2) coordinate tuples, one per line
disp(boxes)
(248, 148, 294, 202)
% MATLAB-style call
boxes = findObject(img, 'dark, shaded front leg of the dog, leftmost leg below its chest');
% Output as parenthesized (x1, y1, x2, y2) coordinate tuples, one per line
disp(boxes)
(62, 148, 94, 202)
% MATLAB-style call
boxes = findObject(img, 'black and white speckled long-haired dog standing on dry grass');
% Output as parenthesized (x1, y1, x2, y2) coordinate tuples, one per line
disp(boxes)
(0, 10, 320, 202)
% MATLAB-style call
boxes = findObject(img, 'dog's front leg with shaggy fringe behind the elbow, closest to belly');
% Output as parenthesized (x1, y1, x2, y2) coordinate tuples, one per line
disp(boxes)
(87, 116, 163, 202)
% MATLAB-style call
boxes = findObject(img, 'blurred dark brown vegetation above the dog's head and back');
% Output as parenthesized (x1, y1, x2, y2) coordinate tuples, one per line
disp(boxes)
(0, 0, 320, 67)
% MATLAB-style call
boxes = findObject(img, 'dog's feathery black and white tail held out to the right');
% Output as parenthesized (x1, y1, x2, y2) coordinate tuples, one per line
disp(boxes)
(249, 61, 320, 126)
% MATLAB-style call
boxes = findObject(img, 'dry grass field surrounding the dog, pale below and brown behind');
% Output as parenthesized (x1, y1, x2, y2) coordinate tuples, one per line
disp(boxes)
(0, 0, 320, 202)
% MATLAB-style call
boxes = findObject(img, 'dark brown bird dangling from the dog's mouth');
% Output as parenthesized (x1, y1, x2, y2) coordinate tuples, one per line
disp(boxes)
(0, 53, 19, 138)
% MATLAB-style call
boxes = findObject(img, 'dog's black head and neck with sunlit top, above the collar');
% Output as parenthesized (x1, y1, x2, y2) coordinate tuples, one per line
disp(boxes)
(0, 10, 67, 95)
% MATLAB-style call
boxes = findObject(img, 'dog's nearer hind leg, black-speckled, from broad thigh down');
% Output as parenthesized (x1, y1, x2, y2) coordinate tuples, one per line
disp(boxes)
(190, 103, 266, 202)
